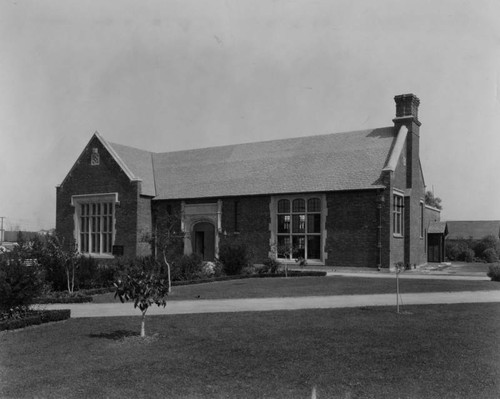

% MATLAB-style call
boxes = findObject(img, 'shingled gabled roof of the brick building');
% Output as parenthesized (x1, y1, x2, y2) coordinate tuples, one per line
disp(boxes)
(104, 127, 397, 199)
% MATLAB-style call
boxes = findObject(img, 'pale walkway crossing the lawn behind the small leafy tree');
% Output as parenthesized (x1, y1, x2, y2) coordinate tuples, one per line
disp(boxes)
(39, 290, 500, 318)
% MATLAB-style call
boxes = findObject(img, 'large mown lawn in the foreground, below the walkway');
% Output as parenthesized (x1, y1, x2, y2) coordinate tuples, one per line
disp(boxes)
(0, 304, 500, 398)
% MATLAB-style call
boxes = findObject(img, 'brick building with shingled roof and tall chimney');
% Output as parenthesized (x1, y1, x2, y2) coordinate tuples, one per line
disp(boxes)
(56, 94, 439, 267)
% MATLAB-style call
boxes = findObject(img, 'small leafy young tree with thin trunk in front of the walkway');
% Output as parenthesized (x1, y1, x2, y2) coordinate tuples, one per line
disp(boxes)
(114, 267, 169, 337)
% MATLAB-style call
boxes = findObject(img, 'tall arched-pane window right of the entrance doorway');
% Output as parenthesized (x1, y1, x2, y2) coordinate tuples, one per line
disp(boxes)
(277, 198, 321, 260)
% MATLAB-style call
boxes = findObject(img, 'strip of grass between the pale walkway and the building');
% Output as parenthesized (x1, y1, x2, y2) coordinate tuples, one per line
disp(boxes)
(94, 276, 500, 303)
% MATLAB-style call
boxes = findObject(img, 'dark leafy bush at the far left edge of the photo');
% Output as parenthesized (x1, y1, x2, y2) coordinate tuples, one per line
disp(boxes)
(0, 253, 43, 312)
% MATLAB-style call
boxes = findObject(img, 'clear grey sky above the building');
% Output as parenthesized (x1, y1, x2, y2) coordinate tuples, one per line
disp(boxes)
(0, 0, 500, 230)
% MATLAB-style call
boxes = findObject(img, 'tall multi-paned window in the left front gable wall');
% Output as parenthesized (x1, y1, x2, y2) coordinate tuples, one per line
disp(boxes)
(73, 195, 116, 255)
